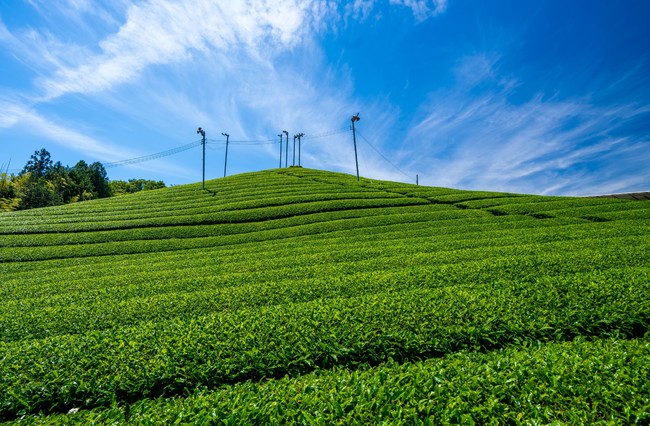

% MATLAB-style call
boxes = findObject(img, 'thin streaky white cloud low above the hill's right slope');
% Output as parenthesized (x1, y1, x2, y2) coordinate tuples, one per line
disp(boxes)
(405, 54, 650, 194)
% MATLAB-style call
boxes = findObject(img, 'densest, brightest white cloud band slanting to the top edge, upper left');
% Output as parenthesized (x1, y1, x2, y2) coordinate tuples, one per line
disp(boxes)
(33, 0, 332, 100)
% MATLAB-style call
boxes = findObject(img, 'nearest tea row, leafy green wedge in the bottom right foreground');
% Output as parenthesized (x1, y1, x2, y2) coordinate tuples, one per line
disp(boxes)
(12, 339, 650, 425)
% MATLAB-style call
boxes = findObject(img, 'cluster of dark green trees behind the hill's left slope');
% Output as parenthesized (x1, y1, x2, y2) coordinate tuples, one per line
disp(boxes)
(0, 148, 165, 211)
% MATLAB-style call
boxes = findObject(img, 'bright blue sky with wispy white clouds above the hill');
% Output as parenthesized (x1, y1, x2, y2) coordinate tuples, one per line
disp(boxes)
(0, 0, 650, 195)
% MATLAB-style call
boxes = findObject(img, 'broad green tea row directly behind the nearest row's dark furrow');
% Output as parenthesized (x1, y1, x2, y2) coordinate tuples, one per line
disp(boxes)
(0, 269, 650, 418)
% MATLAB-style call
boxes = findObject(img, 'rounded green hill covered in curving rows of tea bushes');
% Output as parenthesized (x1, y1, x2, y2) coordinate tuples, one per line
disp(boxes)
(0, 168, 650, 424)
